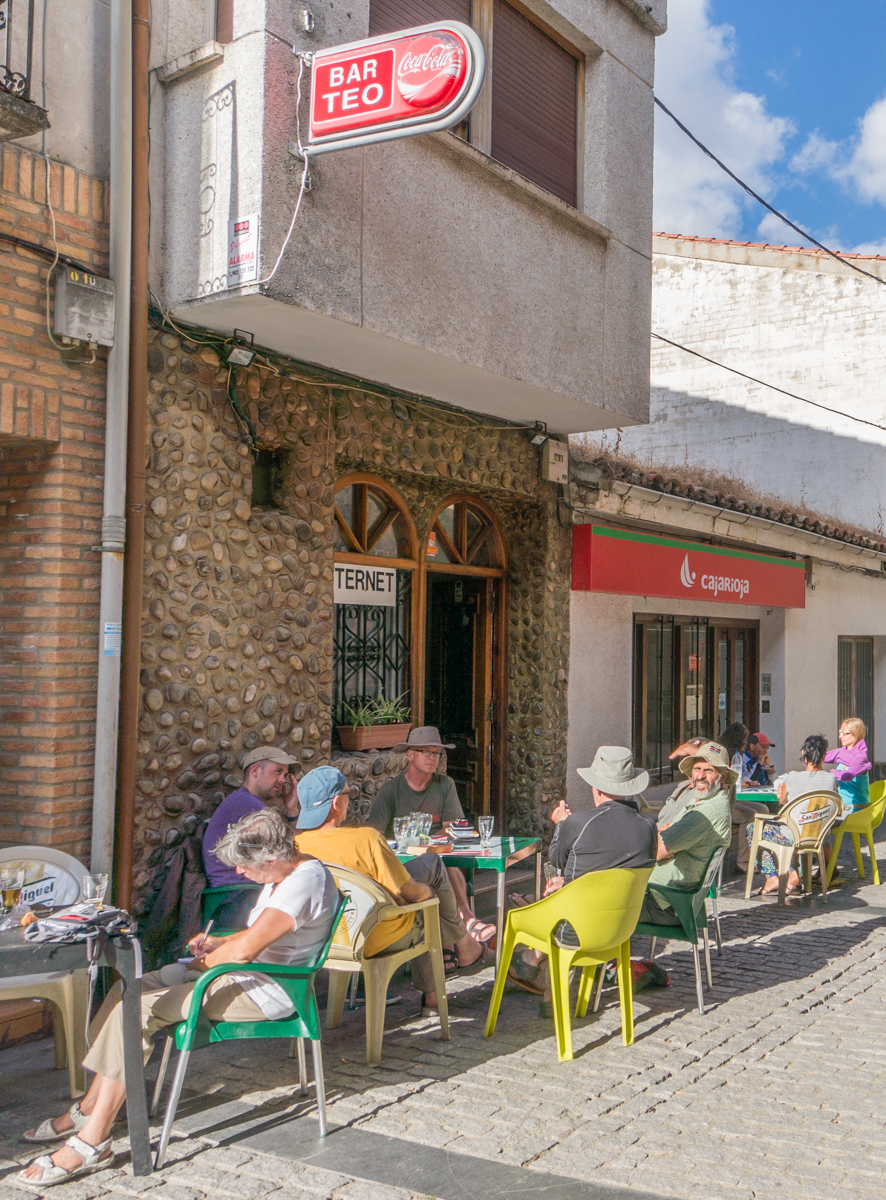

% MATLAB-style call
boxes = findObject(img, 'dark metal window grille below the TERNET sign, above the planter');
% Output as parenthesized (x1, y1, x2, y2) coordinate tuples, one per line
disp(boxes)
(333, 570, 412, 719)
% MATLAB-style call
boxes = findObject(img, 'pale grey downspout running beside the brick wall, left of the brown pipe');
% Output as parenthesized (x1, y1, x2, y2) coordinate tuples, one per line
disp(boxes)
(90, 0, 132, 874)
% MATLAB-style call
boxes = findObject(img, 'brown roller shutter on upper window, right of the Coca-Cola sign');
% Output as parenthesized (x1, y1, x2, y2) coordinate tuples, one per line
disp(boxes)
(492, 0, 579, 205)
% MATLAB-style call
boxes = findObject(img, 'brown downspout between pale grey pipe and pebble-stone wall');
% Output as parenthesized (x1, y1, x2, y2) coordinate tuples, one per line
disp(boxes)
(114, 0, 150, 907)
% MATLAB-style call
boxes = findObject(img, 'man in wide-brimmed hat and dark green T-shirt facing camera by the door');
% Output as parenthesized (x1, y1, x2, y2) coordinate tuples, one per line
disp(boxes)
(366, 725, 496, 944)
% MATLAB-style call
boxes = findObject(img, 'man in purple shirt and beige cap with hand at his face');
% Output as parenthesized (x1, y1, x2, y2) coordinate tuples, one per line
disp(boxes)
(203, 746, 299, 930)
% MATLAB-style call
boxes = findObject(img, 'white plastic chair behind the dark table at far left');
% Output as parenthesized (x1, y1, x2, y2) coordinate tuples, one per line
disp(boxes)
(0, 846, 89, 1099)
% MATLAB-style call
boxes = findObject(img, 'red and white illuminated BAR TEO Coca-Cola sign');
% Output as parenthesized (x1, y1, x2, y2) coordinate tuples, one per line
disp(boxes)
(305, 20, 486, 156)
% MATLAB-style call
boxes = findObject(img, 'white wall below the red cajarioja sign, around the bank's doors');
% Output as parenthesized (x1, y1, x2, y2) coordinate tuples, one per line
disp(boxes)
(567, 564, 886, 809)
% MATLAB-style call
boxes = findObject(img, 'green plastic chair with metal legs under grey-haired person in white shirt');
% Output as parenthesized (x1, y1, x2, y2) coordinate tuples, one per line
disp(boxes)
(151, 894, 347, 1170)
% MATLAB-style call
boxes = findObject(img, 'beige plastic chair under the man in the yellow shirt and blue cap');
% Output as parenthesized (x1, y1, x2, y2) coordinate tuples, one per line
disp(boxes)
(325, 863, 449, 1066)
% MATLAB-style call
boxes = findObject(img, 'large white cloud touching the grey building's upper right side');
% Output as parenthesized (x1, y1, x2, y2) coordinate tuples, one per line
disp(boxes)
(654, 0, 794, 238)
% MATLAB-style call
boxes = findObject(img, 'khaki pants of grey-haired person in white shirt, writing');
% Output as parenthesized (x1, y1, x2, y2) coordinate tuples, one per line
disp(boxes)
(83, 971, 265, 1084)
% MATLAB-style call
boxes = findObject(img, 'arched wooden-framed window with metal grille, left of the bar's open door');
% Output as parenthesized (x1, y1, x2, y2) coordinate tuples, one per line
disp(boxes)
(333, 476, 415, 724)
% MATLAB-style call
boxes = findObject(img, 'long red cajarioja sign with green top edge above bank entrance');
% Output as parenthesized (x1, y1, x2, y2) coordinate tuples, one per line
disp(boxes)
(573, 524, 806, 608)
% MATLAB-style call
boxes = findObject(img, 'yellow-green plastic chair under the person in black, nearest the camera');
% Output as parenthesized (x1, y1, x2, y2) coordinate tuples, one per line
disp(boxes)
(483, 866, 652, 1062)
